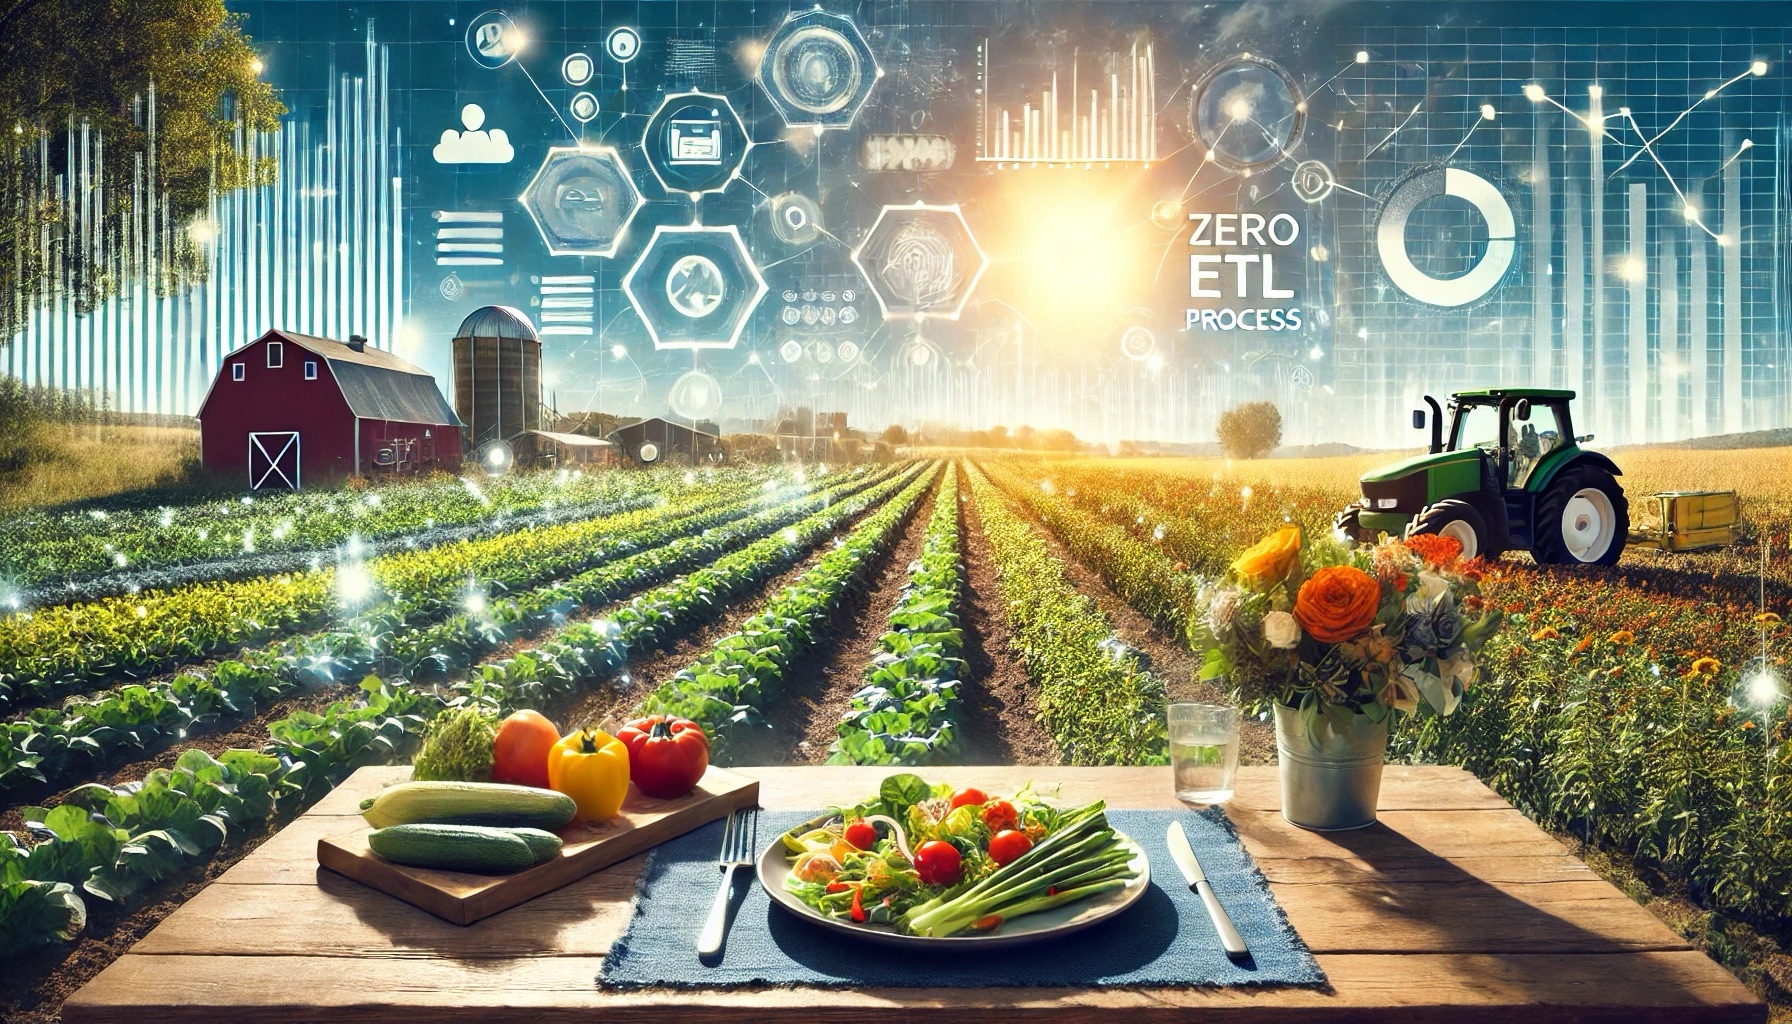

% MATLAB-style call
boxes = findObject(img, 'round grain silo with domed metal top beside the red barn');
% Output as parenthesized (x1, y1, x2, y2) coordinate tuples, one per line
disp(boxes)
(453, 307, 541, 448)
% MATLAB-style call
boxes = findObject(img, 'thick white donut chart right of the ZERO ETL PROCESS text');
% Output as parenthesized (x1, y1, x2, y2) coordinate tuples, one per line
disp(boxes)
(1374, 167, 1518, 308)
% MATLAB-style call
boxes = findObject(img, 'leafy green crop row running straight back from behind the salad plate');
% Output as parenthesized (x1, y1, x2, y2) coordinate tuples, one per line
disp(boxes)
(828, 468, 964, 764)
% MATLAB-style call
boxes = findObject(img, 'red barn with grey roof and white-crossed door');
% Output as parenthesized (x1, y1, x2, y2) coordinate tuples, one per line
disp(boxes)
(199, 330, 461, 490)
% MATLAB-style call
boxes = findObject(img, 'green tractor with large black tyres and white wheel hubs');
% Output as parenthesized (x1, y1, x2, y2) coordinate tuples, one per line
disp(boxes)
(1337, 387, 1631, 565)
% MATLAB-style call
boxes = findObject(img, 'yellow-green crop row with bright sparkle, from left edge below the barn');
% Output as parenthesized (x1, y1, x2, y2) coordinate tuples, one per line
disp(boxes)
(0, 477, 784, 707)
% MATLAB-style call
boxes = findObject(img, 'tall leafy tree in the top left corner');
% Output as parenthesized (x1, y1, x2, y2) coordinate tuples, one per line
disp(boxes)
(0, 0, 285, 346)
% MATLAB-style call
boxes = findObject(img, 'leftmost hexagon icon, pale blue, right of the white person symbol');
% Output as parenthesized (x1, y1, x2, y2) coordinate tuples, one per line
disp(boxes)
(518, 145, 642, 256)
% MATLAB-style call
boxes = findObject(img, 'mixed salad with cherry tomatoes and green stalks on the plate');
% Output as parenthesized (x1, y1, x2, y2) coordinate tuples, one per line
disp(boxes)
(780, 775, 1138, 938)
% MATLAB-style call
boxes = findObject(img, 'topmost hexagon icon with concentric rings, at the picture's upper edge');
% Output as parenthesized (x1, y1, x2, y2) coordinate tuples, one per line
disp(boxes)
(754, 7, 883, 131)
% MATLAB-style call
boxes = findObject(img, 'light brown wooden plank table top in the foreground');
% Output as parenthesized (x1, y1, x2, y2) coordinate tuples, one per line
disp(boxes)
(63, 768, 1767, 1024)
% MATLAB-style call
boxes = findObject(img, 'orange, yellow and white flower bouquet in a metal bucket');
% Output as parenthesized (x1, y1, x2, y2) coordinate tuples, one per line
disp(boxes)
(1190, 525, 1500, 829)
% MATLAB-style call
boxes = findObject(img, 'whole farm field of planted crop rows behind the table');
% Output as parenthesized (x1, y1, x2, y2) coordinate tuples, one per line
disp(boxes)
(0, 448, 1792, 1020)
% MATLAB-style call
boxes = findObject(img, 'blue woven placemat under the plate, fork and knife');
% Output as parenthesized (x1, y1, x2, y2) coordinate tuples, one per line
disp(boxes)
(599, 811, 1326, 988)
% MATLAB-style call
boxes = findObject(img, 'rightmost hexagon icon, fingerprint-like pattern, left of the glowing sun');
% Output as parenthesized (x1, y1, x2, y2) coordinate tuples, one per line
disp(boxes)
(853, 203, 989, 319)
